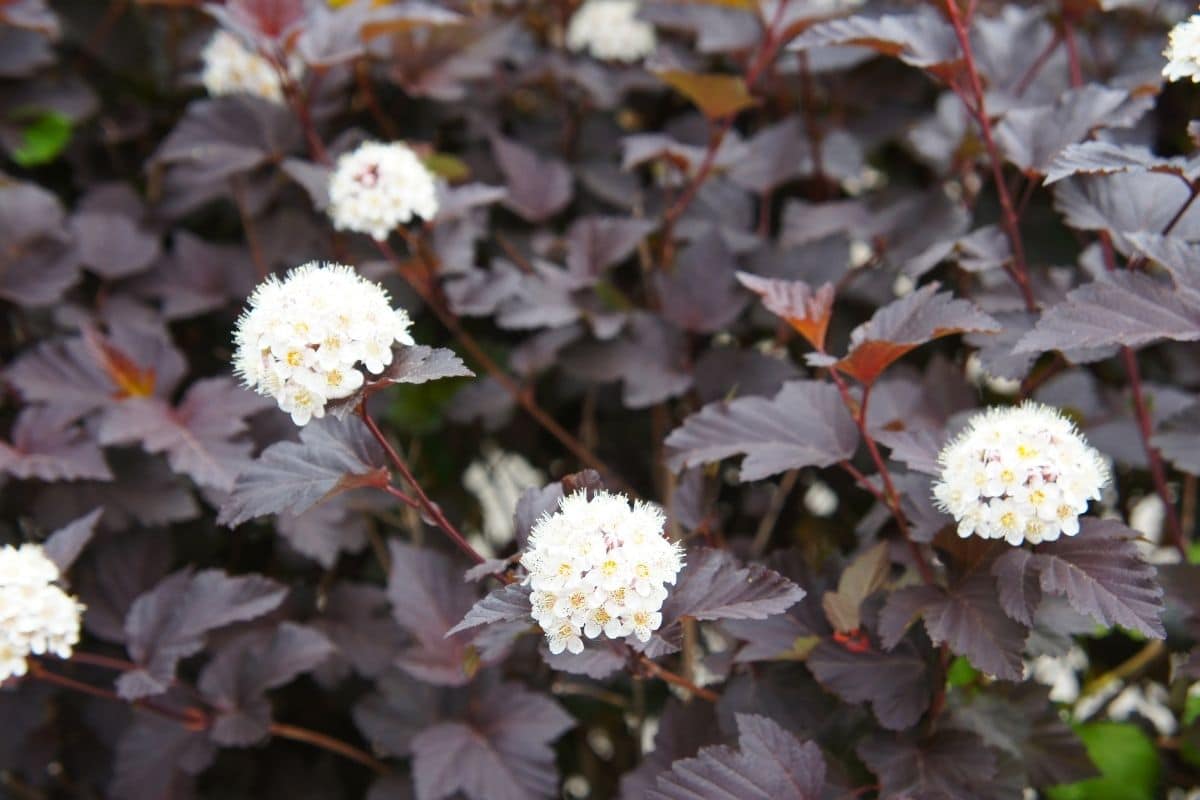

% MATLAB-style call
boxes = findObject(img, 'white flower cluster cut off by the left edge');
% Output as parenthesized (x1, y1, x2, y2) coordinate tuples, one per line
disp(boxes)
(0, 545, 83, 682)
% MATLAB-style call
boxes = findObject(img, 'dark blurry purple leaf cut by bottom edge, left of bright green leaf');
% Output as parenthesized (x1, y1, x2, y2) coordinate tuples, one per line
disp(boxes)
(856, 730, 996, 800)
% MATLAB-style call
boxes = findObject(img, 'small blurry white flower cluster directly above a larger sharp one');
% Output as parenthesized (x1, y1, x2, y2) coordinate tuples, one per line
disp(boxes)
(329, 142, 438, 241)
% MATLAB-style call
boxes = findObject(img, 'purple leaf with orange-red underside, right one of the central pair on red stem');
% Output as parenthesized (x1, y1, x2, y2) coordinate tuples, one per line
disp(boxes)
(836, 283, 1000, 386)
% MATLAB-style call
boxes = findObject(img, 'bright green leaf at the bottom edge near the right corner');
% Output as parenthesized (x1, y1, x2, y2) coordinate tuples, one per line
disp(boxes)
(1046, 722, 1160, 800)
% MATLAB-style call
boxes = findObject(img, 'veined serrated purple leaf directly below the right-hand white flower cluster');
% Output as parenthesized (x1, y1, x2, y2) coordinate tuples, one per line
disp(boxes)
(1033, 519, 1166, 639)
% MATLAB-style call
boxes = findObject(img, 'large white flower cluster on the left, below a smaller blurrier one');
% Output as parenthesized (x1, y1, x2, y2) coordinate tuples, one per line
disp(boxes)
(234, 261, 414, 425)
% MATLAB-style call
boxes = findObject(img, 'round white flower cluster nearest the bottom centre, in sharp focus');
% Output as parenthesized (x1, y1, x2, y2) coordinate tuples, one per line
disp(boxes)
(521, 489, 683, 655)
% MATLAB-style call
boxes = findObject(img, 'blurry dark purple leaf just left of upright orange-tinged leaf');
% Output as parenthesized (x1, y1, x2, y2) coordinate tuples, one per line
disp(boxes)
(654, 228, 746, 333)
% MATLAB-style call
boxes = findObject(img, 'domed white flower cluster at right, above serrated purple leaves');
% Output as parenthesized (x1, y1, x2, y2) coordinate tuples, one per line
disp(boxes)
(934, 402, 1109, 545)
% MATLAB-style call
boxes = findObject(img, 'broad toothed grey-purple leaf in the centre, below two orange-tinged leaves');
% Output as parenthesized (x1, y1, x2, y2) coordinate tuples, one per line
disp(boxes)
(666, 380, 858, 481)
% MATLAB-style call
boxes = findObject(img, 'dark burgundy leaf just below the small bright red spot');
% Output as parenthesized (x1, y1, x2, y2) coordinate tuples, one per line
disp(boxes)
(805, 640, 934, 730)
